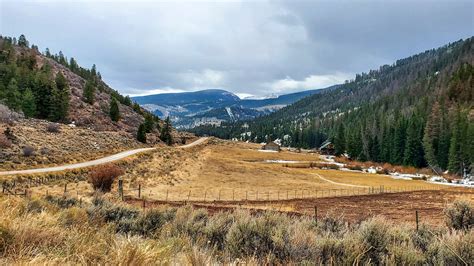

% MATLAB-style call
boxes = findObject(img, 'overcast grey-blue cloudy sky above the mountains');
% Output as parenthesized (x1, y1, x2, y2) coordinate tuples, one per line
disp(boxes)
(0, 0, 474, 97)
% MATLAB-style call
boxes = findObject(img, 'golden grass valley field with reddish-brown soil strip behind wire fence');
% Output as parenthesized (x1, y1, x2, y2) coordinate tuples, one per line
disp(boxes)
(9, 139, 474, 224)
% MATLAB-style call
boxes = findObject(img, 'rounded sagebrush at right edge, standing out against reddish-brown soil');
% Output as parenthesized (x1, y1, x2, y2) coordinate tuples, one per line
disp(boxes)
(444, 200, 474, 230)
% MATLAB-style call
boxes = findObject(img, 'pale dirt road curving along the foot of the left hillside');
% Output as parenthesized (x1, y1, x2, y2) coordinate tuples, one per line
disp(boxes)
(0, 138, 208, 176)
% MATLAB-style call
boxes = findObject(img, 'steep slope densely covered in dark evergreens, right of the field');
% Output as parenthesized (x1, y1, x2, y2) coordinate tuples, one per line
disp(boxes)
(194, 37, 474, 174)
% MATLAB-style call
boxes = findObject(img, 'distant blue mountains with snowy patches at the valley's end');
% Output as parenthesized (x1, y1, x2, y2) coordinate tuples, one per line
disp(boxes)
(132, 85, 338, 128)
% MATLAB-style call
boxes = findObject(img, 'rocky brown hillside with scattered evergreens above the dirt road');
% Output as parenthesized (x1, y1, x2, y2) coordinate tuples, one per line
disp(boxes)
(0, 35, 174, 143)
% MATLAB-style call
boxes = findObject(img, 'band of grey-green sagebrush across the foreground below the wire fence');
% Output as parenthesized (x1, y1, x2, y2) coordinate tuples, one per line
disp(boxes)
(21, 195, 474, 265)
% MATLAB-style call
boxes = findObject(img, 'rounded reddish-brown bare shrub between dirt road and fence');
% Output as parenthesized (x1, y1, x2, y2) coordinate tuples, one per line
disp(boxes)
(88, 164, 124, 192)
